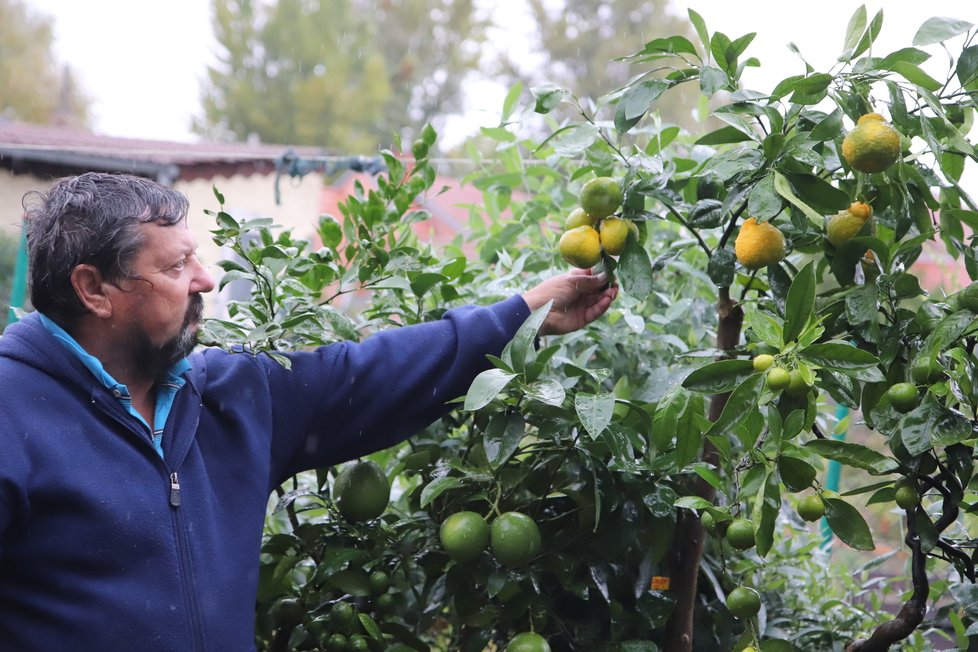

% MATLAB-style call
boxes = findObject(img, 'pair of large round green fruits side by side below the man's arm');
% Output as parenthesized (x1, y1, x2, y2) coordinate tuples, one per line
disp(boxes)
(438, 511, 541, 568)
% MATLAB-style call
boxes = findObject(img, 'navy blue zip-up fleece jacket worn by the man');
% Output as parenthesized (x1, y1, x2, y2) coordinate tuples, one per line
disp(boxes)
(0, 297, 529, 652)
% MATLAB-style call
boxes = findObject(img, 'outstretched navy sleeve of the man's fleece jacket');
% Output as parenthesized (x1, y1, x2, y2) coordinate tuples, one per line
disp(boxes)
(264, 296, 530, 479)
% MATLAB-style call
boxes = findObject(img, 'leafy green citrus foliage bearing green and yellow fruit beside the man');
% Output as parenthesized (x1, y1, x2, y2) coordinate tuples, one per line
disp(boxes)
(200, 7, 978, 652)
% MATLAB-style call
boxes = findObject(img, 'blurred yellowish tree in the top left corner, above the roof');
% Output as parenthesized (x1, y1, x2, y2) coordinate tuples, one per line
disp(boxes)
(0, 0, 90, 126)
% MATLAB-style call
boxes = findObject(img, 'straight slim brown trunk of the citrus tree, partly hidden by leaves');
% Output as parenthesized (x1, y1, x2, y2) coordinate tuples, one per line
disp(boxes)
(663, 288, 744, 652)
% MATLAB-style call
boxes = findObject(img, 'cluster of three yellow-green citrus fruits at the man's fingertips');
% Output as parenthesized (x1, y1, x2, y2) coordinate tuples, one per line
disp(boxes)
(558, 177, 638, 269)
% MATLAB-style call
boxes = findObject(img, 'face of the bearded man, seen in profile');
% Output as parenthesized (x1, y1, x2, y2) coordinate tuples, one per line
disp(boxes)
(113, 222, 214, 377)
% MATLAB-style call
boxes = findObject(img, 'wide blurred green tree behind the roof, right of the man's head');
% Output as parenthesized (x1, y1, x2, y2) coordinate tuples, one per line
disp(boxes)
(194, 0, 485, 152)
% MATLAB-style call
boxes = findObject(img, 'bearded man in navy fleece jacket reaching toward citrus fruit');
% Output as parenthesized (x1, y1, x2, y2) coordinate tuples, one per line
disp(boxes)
(0, 173, 616, 652)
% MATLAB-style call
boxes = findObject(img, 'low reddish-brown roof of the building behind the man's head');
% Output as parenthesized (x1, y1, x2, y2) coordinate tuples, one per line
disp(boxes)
(0, 119, 325, 183)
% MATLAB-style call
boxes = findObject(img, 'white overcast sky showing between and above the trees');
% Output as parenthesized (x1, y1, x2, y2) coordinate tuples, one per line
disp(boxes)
(27, 0, 978, 141)
